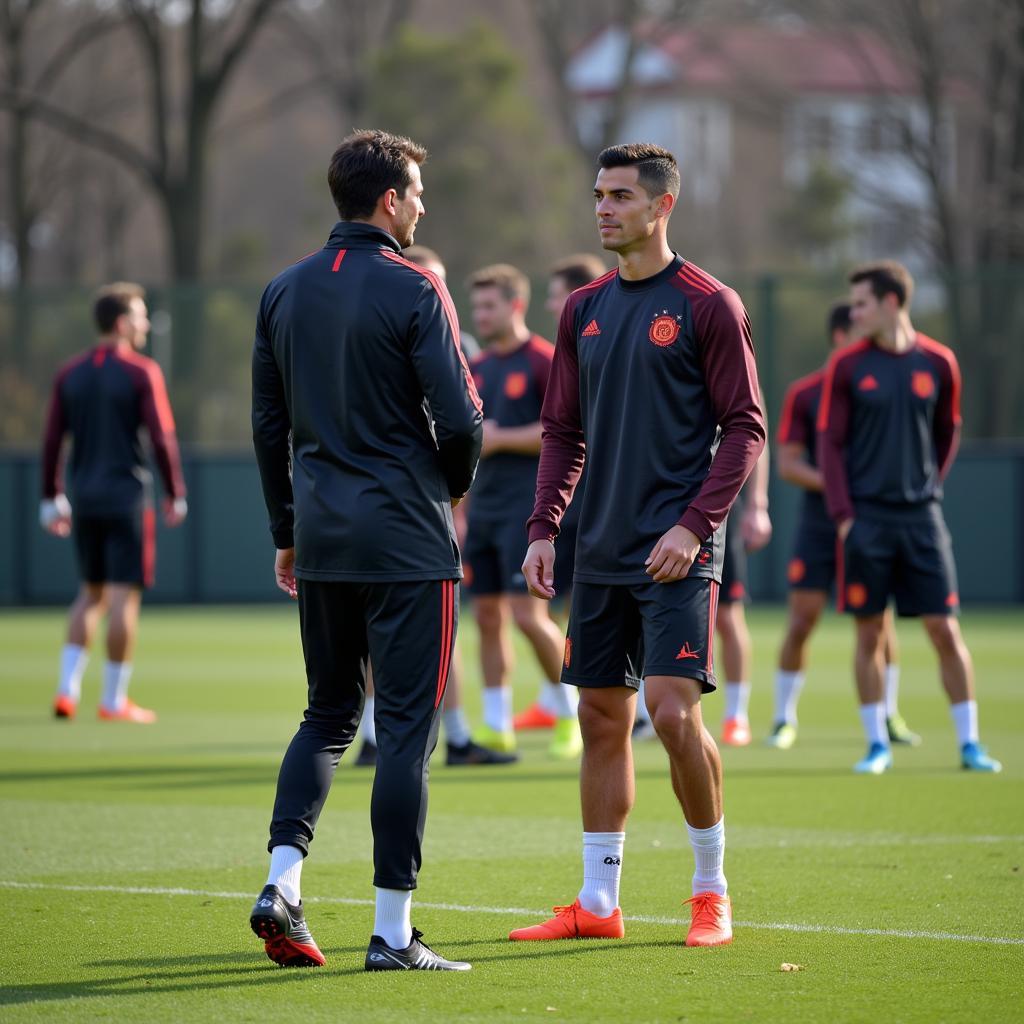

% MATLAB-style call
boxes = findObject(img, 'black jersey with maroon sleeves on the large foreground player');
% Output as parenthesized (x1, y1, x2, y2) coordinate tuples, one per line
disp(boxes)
(529, 256, 765, 583)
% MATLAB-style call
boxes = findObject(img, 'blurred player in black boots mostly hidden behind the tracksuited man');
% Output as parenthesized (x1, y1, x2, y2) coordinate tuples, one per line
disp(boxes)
(355, 245, 518, 768)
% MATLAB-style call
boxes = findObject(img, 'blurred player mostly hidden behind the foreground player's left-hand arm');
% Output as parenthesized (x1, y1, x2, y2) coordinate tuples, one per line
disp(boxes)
(512, 253, 607, 732)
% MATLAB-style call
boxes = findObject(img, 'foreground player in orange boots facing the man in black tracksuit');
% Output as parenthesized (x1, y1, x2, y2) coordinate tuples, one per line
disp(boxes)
(510, 143, 765, 946)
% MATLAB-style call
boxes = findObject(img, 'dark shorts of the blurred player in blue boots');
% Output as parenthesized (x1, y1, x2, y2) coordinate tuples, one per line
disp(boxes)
(837, 505, 959, 615)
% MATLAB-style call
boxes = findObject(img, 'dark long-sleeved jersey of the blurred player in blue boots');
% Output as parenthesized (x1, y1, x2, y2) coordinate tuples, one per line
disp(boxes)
(817, 332, 961, 522)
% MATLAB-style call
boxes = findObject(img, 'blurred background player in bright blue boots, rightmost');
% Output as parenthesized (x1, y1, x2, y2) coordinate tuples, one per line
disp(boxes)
(817, 260, 1001, 775)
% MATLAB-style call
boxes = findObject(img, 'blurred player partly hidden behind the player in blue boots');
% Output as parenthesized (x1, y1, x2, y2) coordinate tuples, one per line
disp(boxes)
(766, 302, 921, 751)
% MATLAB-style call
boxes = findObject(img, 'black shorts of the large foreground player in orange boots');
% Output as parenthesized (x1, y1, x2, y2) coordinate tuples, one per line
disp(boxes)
(562, 577, 719, 693)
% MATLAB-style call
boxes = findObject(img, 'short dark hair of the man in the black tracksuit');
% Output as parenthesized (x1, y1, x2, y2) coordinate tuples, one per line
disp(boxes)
(327, 129, 427, 220)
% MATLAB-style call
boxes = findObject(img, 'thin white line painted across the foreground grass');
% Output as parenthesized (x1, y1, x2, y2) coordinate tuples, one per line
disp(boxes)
(0, 880, 1024, 946)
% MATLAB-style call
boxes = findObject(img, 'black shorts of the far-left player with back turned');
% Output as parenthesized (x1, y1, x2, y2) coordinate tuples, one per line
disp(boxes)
(72, 507, 157, 587)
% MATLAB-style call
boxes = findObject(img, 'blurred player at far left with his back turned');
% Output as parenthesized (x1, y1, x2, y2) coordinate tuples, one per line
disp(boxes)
(39, 282, 188, 725)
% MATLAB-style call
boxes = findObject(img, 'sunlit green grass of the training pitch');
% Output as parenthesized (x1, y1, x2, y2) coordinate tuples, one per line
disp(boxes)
(0, 608, 1024, 1024)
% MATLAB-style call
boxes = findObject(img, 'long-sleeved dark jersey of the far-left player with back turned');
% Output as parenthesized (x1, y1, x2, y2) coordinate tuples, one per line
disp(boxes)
(43, 345, 185, 516)
